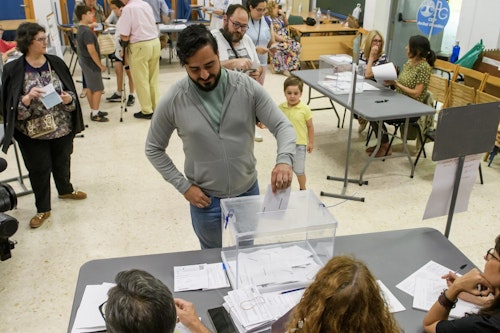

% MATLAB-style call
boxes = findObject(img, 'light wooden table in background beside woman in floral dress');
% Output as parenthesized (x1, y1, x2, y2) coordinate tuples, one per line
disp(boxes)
(289, 23, 358, 68)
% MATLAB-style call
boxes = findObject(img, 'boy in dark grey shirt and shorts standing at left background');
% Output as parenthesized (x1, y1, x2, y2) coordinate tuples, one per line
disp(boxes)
(75, 4, 109, 123)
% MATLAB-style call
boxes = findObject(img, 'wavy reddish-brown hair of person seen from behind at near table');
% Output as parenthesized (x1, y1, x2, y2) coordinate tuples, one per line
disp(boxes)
(287, 256, 401, 333)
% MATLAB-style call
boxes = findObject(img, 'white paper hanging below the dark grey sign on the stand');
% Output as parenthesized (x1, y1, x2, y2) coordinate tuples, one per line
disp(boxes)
(423, 154, 482, 220)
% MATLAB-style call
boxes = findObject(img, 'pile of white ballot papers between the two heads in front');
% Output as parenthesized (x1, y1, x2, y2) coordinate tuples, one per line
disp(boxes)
(224, 286, 304, 333)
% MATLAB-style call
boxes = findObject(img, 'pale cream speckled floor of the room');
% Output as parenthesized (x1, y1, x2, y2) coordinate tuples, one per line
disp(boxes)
(0, 55, 500, 332)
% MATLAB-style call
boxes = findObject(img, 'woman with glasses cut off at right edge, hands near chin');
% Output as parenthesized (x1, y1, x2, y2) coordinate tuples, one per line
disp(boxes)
(423, 235, 500, 333)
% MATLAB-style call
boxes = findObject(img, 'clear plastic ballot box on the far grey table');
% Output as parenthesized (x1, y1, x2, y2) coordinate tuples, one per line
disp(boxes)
(318, 54, 365, 94)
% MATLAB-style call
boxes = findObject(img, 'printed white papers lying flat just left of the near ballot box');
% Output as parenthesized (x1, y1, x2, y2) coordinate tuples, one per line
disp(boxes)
(174, 262, 229, 292)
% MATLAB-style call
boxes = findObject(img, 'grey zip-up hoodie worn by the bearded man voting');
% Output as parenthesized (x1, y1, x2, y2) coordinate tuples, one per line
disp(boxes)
(146, 68, 295, 198)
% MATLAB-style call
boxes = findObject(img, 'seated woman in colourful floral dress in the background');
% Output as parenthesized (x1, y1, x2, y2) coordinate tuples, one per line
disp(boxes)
(267, 0, 301, 76)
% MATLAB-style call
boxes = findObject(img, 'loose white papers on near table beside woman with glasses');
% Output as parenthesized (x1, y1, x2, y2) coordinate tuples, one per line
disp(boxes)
(396, 260, 479, 318)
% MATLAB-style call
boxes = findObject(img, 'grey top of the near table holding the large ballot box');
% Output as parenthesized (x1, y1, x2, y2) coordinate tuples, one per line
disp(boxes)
(68, 228, 475, 333)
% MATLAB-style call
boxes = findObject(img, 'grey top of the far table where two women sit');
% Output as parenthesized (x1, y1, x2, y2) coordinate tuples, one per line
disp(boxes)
(293, 69, 436, 121)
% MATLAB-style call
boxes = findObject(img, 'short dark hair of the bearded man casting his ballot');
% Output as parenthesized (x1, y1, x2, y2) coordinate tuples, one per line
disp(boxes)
(176, 24, 219, 66)
